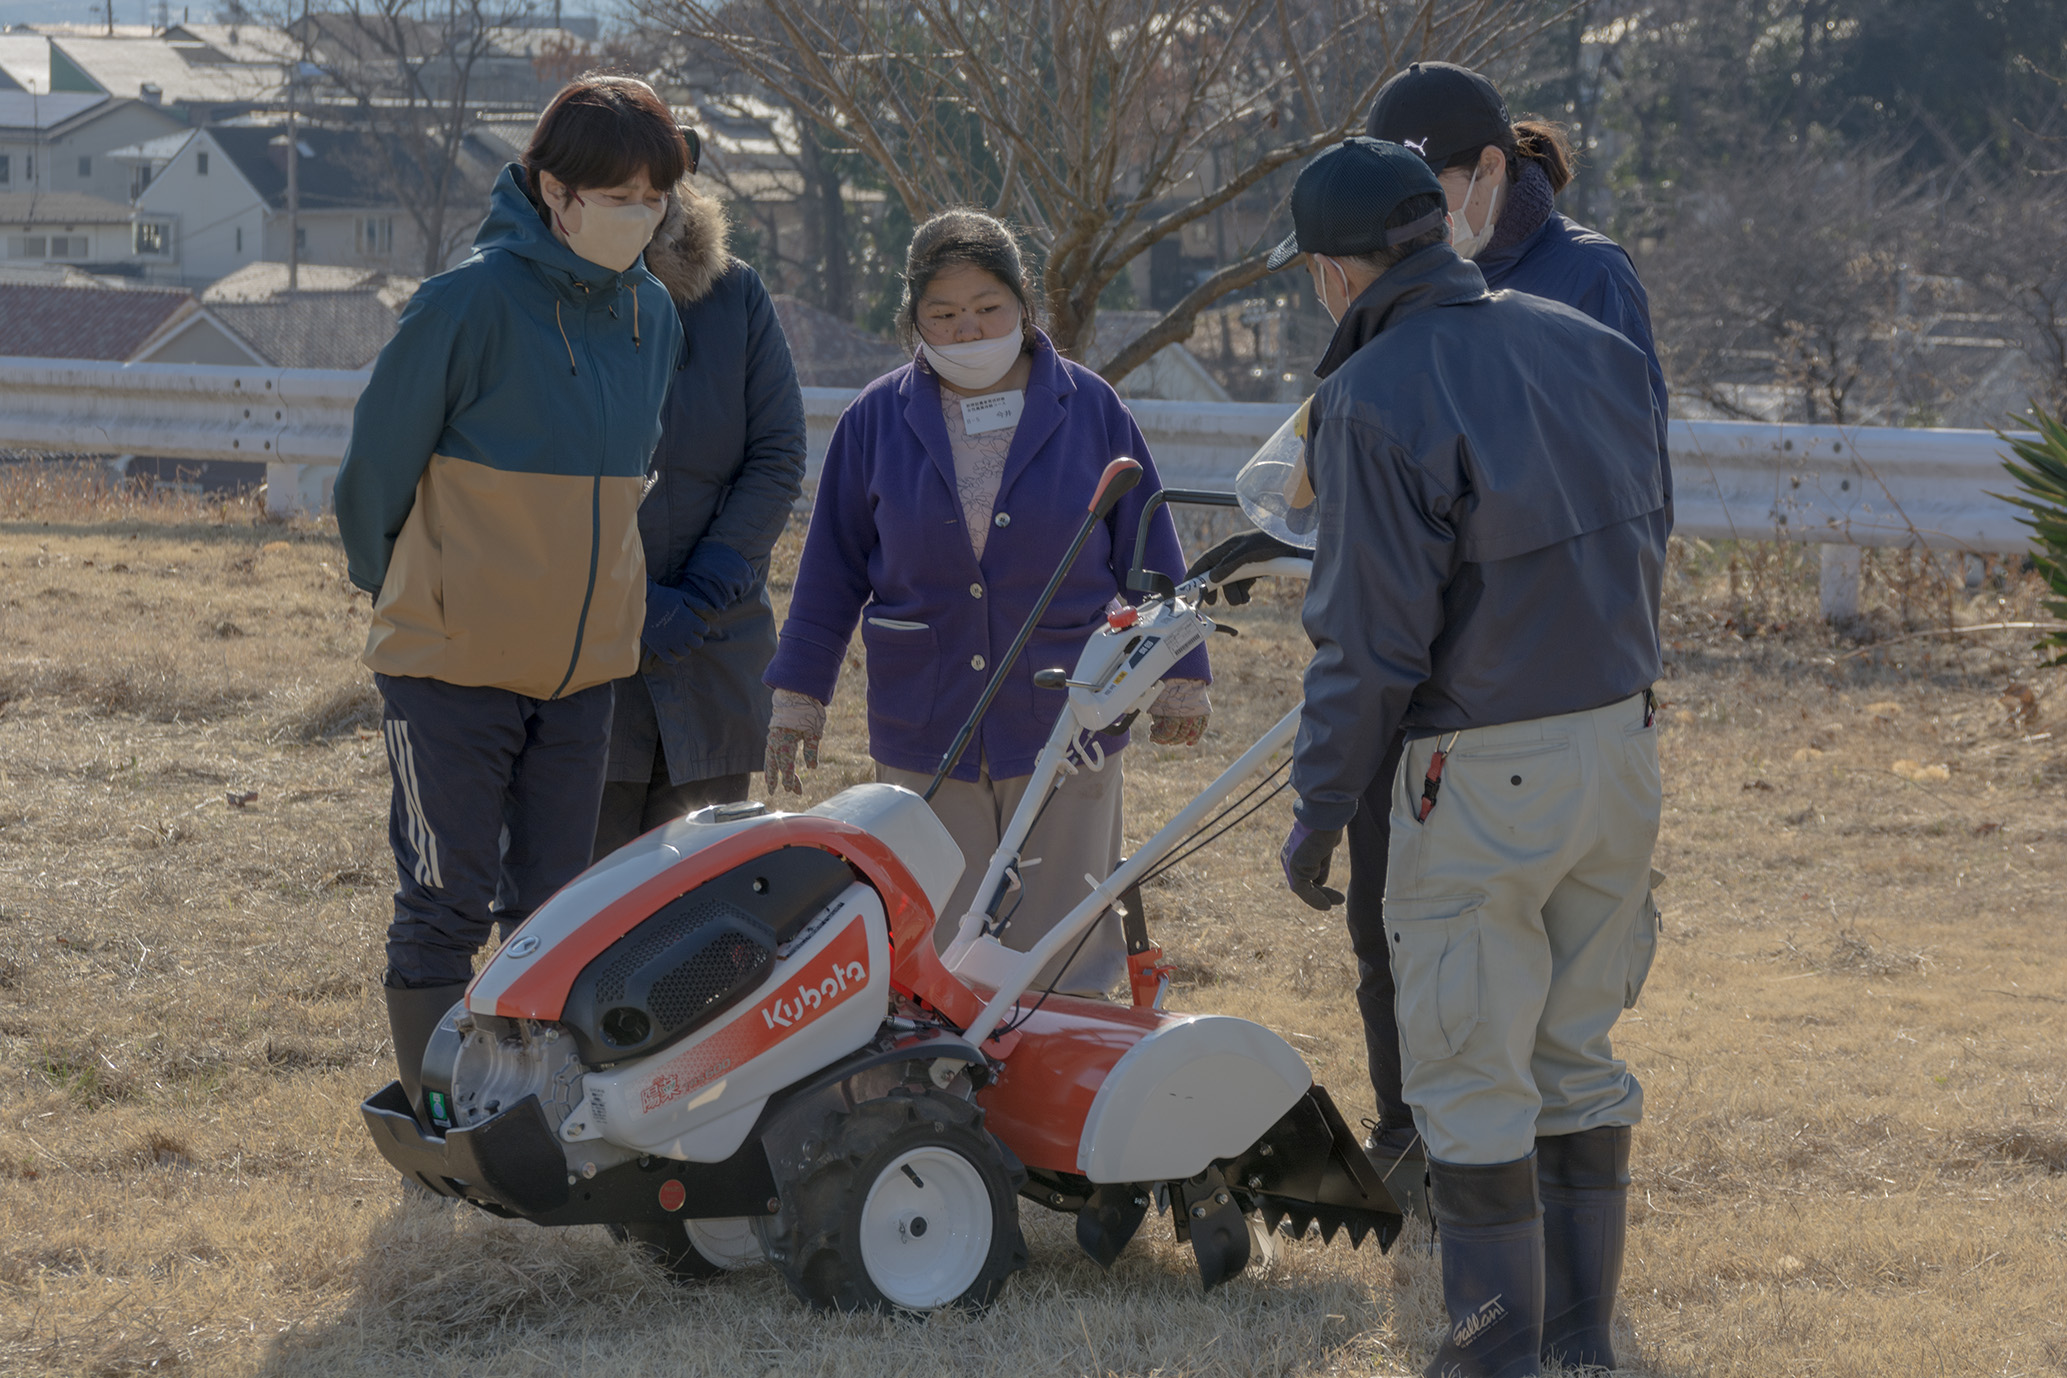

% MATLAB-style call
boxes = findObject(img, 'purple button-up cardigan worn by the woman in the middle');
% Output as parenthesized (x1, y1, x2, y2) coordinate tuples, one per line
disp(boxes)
(763, 335, 1209, 781)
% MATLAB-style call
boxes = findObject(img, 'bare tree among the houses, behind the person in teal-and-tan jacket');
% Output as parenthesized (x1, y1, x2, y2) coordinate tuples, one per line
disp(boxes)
(300, 0, 535, 277)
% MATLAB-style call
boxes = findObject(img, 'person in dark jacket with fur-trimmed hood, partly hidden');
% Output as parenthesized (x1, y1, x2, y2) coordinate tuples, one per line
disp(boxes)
(595, 155, 804, 859)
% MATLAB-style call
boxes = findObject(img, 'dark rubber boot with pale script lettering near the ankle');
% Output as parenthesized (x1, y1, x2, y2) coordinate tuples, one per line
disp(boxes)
(1426, 1153, 1544, 1378)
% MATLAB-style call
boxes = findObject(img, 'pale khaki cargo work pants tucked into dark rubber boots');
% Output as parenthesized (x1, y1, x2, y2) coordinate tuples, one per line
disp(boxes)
(1385, 694, 1660, 1163)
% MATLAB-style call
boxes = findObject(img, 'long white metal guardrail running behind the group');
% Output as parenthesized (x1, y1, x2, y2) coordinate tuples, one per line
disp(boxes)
(0, 357, 2030, 616)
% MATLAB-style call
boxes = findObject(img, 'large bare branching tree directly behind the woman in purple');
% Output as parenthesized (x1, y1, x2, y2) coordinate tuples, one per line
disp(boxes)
(637, 0, 1571, 378)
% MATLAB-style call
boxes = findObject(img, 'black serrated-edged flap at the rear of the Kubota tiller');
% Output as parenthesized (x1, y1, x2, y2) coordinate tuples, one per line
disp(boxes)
(1224, 1085, 1406, 1250)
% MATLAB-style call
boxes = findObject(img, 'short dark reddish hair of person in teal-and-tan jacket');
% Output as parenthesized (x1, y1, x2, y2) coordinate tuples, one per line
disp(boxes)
(523, 72, 688, 194)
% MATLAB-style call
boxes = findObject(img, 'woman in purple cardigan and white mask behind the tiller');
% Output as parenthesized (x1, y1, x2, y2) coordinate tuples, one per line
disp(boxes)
(763, 211, 1209, 996)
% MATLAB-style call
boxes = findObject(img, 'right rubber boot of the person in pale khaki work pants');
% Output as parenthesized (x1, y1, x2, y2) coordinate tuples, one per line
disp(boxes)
(1536, 1124, 1629, 1370)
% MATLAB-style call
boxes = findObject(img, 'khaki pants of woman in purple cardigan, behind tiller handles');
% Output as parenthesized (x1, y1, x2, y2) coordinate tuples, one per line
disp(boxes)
(876, 754, 1127, 998)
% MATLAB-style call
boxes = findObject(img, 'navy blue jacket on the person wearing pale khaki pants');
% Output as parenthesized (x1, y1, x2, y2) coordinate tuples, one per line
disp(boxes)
(1292, 244, 1670, 828)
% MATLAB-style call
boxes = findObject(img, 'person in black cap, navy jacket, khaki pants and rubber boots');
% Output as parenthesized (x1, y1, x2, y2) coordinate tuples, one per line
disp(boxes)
(1271, 138, 1670, 1378)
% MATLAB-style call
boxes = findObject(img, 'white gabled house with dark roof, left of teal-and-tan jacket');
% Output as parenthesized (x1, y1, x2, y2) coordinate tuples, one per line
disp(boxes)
(136, 124, 444, 285)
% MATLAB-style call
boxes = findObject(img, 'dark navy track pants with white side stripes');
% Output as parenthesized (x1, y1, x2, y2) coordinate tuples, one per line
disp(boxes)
(374, 676, 612, 988)
